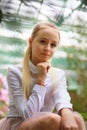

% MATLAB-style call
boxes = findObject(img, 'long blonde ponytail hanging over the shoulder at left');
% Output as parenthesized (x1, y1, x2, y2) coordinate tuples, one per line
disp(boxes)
(22, 45, 31, 99)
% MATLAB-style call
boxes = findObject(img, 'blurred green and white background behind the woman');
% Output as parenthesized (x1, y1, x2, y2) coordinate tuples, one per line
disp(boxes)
(0, 0, 87, 120)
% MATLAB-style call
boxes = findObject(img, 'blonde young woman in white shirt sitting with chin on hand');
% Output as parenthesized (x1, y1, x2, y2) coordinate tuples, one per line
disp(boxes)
(0, 22, 85, 130)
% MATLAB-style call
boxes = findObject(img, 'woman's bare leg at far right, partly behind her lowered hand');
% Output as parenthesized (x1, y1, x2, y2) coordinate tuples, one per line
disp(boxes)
(74, 112, 86, 130)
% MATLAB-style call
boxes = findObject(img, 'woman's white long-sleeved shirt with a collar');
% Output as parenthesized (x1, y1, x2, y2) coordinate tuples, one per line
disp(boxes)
(7, 62, 72, 119)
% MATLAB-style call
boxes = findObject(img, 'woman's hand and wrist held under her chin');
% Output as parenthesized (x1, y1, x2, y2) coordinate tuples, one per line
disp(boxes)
(36, 62, 50, 86)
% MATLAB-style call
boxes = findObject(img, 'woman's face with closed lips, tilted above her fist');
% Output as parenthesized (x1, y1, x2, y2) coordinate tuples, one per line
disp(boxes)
(29, 27, 59, 65)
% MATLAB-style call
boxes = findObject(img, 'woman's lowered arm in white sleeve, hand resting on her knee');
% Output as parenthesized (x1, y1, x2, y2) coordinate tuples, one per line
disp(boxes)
(53, 70, 78, 130)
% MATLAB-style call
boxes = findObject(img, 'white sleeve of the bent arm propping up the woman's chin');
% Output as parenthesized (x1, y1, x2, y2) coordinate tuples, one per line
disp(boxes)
(7, 68, 46, 119)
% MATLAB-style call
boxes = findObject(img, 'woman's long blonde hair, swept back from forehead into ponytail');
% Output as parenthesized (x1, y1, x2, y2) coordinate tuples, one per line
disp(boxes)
(22, 22, 60, 99)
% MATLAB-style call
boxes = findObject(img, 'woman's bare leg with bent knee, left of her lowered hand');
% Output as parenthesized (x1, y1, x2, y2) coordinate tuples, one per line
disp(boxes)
(18, 113, 61, 130)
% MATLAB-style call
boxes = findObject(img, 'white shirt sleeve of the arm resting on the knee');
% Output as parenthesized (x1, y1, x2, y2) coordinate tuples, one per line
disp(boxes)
(53, 70, 72, 113)
